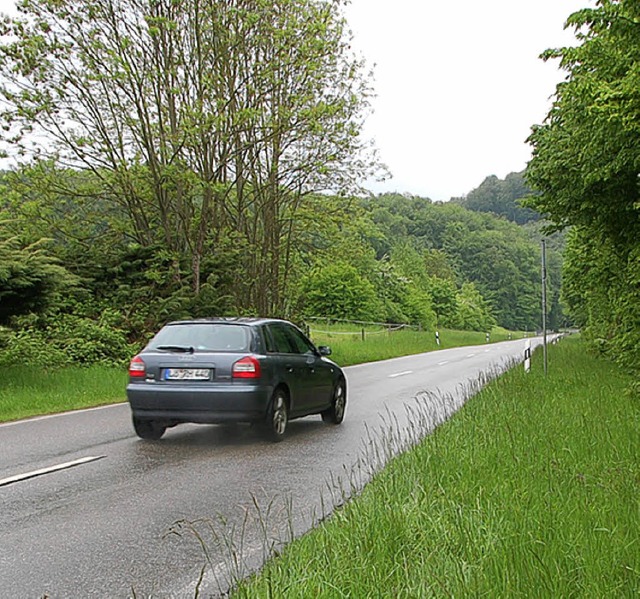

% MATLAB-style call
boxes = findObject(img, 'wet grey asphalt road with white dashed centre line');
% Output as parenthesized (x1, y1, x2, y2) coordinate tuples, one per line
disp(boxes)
(0, 338, 552, 599)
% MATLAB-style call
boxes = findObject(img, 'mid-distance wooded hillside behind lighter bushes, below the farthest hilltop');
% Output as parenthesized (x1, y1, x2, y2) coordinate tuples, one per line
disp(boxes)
(367, 194, 548, 330)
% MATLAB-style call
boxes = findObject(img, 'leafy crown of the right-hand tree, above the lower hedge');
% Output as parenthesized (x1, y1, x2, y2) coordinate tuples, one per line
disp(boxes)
(527, 0, 640, 244)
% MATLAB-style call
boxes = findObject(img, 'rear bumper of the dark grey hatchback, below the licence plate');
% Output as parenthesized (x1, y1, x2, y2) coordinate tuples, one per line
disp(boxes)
(127, 382, 272, 424)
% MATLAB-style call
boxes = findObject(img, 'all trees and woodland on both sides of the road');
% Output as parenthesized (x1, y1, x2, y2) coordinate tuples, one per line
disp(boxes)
(0, 0, 640, 380)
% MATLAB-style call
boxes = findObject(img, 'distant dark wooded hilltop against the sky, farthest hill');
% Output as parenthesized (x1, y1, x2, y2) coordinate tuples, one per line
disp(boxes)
(451, 171, 540, 225)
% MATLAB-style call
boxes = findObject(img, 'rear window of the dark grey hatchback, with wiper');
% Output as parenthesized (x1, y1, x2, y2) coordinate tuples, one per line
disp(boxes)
(148, 323, 251, 352)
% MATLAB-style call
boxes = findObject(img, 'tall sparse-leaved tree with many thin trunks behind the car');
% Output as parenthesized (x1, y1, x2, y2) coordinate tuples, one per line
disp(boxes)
(0, 0, 377, 313)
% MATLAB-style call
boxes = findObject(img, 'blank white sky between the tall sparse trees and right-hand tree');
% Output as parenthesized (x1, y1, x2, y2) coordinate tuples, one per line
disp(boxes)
(0, 0, 594, 200)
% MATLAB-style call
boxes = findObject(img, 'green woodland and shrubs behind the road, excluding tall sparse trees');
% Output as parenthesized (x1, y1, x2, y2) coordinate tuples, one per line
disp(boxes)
(0, 163, 564, 364)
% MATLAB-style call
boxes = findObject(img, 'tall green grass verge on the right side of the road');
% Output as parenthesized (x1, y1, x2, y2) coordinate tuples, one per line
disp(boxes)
(233, 339, 640, 599)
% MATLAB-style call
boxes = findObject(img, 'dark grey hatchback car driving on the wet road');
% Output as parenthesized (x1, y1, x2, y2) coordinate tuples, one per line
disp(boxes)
(127, 318, 347, 441)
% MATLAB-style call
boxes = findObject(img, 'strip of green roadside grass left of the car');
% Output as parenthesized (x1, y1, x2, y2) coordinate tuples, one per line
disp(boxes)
(0, 366, 127, 422)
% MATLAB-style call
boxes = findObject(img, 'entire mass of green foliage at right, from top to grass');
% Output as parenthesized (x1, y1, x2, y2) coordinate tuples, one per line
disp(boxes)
(527, 0, 640, 368)
